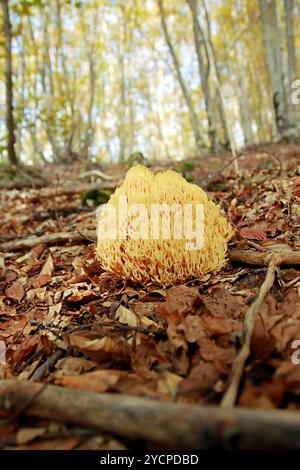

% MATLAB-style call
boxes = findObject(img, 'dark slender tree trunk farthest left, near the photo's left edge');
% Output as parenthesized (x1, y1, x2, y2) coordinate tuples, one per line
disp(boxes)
(1, 0, 18, 165)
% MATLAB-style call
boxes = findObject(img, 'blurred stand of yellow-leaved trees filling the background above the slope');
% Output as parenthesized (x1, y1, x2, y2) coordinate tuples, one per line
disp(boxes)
(0, 0, 300, 164)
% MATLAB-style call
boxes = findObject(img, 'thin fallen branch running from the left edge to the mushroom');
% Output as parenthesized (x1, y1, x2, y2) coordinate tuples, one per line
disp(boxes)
(0, 230, 96, 252)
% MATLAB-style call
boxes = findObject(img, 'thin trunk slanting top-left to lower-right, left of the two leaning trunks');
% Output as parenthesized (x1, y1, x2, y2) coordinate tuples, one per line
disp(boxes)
(157, 0, 204, 151)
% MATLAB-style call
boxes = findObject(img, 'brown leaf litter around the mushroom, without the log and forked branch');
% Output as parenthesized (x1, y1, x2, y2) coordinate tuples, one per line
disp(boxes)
(0, 145, 300, 449)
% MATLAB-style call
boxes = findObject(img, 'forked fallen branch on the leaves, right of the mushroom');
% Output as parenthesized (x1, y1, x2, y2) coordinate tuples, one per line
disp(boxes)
(220, 250, 300, 408)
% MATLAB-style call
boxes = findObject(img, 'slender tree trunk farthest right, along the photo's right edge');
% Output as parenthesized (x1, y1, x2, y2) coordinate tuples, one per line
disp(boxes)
(284, 0, 298, 138)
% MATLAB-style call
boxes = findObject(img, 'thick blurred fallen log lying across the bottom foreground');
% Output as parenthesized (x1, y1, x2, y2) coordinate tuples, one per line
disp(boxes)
(0, 380, 300, 449)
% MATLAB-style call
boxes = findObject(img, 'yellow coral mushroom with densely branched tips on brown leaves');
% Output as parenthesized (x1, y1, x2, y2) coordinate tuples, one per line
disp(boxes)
(97, 165, 234, 286)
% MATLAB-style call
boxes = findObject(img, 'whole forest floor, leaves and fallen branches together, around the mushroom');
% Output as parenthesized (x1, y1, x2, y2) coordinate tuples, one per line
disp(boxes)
(0, 144, 300, 450)
